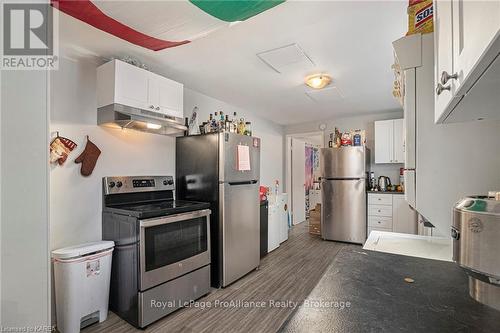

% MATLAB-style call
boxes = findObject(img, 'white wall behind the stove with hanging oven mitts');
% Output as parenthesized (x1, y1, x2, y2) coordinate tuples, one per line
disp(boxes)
(50, 59, 175, 249)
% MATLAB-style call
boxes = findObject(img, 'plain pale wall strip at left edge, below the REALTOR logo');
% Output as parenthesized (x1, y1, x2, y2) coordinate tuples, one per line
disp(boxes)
(0, 71, 50, 327)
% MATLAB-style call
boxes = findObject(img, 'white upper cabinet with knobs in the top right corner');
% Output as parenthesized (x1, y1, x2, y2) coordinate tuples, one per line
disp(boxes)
(434, 0, 500, 123)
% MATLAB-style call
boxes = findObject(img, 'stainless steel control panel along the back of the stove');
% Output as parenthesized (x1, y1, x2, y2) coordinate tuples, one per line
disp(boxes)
(102, 176, 174, 195)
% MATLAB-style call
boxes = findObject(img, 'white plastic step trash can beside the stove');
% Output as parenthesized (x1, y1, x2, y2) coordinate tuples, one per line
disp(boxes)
(52, 241, 115, 333)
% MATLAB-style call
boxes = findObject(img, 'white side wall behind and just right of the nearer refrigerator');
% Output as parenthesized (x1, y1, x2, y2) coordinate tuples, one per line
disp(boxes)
(184, 88, 284, 188)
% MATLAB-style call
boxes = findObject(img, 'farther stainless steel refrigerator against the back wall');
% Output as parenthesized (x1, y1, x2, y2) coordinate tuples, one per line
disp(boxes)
(320, 147, 370, 244)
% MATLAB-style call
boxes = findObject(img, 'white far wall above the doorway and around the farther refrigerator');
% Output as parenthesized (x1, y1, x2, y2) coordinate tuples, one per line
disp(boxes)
(285, 110, 404, 184)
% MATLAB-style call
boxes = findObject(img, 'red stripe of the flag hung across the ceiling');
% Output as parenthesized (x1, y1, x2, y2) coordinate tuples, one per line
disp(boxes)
(51, 0, 189, 51)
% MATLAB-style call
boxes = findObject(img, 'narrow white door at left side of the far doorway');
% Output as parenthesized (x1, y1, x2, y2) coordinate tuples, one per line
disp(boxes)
(291, 138, 306, 224)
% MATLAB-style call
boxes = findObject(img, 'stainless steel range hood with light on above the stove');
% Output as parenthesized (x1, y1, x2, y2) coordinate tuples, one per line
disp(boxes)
(97, 103, 187, 136)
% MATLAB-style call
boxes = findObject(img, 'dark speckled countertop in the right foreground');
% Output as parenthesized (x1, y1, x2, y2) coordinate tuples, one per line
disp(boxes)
(280, 246, 500, 332)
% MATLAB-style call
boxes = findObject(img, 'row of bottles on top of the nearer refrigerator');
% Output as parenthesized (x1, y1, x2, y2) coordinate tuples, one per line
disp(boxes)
(200, 111, 252, 136)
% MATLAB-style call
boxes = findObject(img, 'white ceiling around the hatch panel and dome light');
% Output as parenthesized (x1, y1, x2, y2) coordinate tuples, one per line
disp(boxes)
(59, 1, 407, 125)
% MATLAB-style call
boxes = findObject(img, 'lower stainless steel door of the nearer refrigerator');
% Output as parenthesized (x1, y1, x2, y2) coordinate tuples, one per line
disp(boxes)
(220, 183, 260, 287)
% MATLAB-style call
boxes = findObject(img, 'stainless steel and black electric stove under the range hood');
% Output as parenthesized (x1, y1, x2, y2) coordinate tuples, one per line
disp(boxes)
(102, 176, 211, 328)
